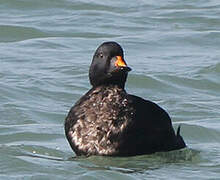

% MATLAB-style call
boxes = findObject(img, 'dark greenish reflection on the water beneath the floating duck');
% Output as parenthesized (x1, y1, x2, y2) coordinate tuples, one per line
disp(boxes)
(69, 148, 201, 174)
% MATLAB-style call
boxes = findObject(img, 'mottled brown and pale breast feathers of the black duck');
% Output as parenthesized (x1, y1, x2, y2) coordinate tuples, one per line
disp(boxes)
(69, 86, 134, 155)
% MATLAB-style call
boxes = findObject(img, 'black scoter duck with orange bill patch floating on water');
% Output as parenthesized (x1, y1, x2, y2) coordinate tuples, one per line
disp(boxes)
(65, 42, 186, 156)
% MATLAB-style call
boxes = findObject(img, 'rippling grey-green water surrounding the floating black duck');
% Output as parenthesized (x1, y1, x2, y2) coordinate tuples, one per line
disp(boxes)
(0, 0, 220, 179)
